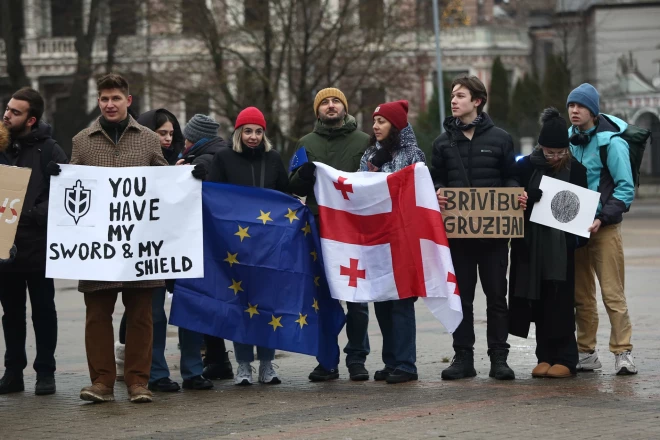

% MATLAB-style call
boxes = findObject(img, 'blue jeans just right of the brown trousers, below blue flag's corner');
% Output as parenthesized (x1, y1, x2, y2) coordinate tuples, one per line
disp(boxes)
(149, 287, 204, 383)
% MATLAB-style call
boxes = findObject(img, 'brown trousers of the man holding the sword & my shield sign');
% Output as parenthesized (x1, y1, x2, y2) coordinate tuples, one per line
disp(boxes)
(85, 289, 154, 388)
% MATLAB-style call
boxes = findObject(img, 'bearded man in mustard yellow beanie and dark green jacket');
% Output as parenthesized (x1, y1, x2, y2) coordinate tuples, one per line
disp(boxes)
(290, 88, 369, 382)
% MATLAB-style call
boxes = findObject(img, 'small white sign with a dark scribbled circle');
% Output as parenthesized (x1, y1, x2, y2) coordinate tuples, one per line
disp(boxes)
(529, 176, 600, 238)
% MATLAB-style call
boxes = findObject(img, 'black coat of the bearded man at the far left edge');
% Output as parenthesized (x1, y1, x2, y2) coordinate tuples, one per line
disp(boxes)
(0, 121, 69, 272)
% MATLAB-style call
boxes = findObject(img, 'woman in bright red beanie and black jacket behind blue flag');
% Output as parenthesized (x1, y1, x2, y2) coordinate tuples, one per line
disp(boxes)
(206, 107, 289, 385)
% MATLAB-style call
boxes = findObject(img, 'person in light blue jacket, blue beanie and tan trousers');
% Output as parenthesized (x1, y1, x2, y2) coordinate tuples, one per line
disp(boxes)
(566, 83, 637, 375)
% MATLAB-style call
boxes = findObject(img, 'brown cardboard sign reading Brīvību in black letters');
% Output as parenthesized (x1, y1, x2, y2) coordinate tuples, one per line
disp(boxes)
(441, 188, 525, 238)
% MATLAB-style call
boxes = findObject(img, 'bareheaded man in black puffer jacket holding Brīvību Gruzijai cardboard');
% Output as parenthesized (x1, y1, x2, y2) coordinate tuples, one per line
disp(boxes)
(433, 76, 520, 380)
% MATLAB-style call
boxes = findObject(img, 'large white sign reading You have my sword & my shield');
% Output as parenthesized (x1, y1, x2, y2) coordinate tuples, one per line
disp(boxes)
(46, 165, 204, 281)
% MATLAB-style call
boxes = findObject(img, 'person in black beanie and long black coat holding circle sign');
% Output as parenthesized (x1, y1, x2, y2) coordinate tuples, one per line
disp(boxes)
(509, 107, 587, 378)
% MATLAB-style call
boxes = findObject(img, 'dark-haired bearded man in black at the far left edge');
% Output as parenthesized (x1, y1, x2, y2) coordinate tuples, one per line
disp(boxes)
(0, 87, 68, 395)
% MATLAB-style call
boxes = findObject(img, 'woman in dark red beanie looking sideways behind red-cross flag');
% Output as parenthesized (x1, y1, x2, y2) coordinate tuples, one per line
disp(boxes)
(360, 101, 426, 383)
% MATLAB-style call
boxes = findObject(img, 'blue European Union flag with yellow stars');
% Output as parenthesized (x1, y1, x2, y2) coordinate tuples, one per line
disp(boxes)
(170, 182, 345, 369)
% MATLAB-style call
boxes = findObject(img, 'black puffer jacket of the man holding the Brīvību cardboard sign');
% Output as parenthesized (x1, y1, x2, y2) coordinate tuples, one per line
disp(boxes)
(432, 113, 520, 188)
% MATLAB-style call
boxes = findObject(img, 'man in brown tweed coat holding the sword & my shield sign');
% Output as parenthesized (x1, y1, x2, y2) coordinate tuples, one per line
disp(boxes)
(63, 74, 167, 402)
